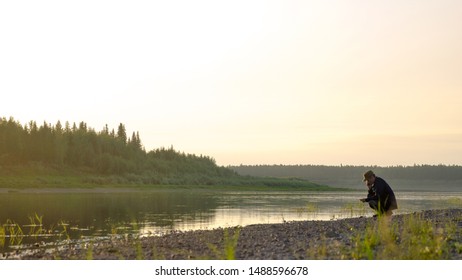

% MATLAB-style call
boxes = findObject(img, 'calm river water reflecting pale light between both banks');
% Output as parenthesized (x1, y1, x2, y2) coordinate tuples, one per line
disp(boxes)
(0, 189, 462, 251)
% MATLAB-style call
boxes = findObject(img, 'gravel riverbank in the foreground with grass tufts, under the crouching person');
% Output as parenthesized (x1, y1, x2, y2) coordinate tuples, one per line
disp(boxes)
(1, 209, 462, 260)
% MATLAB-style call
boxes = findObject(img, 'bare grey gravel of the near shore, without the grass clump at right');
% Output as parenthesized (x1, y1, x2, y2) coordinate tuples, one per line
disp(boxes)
(4, 209, 462, 260)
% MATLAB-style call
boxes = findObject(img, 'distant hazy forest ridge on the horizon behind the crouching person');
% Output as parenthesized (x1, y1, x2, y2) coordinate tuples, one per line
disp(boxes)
(229, 164, 462, 191)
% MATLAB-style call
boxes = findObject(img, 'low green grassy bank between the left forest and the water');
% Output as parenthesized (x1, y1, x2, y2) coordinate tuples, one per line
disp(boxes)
(0, 163, 345, 191)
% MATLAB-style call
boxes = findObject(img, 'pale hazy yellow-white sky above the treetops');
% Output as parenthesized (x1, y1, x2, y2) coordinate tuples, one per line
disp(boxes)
(0, 0, 462, 165)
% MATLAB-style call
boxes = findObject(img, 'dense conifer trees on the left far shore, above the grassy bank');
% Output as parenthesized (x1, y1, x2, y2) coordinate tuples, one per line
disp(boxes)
(0, 117, 238, 184)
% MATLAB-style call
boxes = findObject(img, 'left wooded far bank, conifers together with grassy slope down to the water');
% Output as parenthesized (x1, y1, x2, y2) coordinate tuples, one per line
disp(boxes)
(0, 117, 326, 187)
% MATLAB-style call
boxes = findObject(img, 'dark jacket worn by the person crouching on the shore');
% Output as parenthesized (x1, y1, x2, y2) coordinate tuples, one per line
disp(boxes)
(366, 177, 398, 211)
